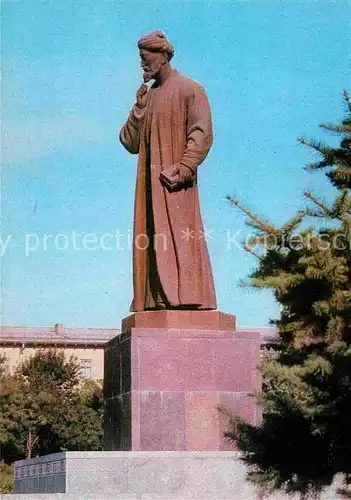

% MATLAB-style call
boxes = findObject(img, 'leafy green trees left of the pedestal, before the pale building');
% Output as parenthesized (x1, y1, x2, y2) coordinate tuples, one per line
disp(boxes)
(0, 350, 103, 463)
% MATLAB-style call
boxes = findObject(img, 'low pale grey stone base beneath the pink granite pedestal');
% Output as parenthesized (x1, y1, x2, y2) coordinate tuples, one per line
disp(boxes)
(13, 451, 342, 500)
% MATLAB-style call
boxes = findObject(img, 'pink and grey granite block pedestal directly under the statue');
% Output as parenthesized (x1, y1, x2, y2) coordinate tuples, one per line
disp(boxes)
(104, 311, 260, 451)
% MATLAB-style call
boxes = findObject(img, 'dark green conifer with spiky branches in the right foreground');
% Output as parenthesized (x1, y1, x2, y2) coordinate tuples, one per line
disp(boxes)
(227, 92, 351, 498)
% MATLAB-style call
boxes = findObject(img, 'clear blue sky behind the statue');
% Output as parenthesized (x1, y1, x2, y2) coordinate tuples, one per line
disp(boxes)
(1, 0, 350, 328)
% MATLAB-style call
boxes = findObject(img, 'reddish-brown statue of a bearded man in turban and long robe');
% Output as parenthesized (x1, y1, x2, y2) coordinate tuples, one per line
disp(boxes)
(120, 31, 217, 311)
